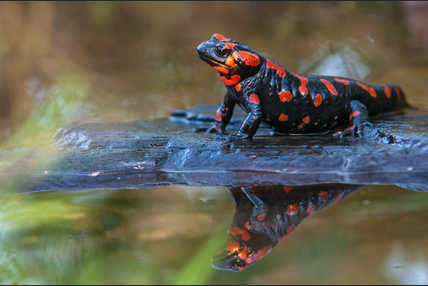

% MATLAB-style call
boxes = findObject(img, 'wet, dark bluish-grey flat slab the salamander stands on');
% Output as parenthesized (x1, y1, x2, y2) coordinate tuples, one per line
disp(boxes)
(9, 106, 428, 191)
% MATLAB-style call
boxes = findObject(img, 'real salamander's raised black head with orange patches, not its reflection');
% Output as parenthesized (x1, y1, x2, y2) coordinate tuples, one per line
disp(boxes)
(197, 34, 264, 85)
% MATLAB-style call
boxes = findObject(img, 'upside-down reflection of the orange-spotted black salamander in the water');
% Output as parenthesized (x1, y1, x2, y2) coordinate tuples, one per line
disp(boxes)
(212, 184, 361, 271)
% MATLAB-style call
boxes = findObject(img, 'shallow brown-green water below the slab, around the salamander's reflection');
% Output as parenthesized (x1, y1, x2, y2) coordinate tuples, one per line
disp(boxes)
(1, 186, 428, 284)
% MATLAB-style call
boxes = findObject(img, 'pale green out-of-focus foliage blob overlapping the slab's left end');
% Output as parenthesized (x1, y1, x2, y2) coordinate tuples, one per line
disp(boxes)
(0, 74, 89, 196)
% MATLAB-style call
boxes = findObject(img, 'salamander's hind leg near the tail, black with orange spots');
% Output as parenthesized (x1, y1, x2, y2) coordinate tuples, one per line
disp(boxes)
(334, 100, 373, 138)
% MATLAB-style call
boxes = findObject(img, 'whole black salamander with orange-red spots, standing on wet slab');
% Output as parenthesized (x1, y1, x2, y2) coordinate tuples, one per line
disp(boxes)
(197, 34, 408, 139)
